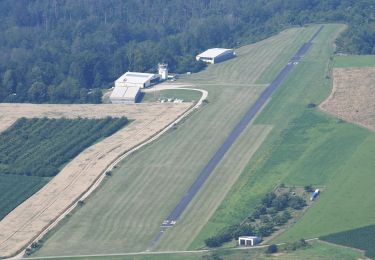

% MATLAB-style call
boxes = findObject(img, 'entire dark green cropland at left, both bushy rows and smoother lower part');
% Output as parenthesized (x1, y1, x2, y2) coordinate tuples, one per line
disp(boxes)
(0, 118, 128, 220)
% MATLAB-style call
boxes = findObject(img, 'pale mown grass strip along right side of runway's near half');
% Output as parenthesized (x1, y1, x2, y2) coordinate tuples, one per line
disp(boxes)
(156, 125, 272, 251)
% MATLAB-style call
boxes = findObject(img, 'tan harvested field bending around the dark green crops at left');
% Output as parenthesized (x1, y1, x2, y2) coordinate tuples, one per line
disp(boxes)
(0, 103, 191, 258)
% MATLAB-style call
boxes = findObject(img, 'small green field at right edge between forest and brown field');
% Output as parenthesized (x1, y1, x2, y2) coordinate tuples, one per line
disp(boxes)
(334, 55, 375, 68)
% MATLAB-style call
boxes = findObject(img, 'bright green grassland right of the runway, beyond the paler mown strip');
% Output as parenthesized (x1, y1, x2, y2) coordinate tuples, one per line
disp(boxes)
(190, 25, 375, 248)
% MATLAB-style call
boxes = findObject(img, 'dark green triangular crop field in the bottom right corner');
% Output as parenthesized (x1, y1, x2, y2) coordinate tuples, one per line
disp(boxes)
(320, 225, 375, 258)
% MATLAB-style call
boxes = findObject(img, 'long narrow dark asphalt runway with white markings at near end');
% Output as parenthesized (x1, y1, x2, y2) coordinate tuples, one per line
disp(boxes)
(148, 25, 324, 250)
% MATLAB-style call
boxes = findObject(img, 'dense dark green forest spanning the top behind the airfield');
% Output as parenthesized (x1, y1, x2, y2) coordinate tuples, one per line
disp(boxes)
(0, 0, 375, 103)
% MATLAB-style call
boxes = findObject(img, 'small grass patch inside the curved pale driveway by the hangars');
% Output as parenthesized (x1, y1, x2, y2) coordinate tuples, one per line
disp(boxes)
(141, 87, 202, 102)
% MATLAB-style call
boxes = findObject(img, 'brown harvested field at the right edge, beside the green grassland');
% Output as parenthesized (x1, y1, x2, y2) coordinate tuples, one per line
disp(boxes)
(320, 68, 375, 131)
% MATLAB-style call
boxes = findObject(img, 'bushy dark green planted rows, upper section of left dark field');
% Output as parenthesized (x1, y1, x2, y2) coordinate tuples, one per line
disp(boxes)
(0, 117, 128, 177)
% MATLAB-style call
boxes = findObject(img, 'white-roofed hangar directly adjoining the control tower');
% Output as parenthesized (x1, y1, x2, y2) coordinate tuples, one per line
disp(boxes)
(115, 71, 160, 88)
